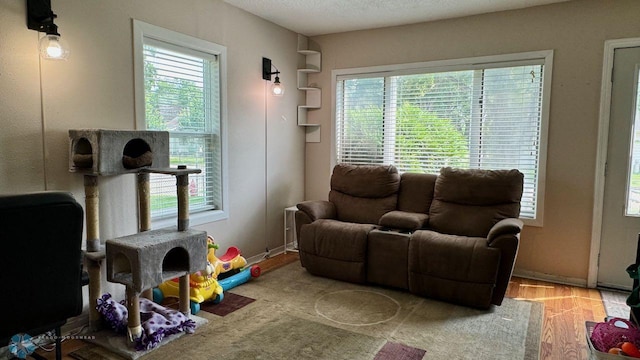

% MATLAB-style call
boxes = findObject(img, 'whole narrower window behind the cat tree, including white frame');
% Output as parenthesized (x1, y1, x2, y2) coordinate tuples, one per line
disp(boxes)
(134, 21, 226, 224)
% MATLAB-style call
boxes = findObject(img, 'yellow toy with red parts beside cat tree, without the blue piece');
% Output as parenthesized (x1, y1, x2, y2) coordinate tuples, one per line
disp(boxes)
(153, 236, 247, 314)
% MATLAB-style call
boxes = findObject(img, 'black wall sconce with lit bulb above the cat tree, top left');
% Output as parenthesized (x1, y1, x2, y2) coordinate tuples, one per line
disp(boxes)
(27, 0, 69, 60)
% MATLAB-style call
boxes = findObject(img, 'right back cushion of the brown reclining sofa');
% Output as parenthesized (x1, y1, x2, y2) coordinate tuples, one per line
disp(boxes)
(429, 168, 524, 237)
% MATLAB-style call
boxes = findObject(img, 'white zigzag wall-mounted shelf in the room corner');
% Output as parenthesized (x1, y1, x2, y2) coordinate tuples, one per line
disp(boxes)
(298, 35, 322, 142)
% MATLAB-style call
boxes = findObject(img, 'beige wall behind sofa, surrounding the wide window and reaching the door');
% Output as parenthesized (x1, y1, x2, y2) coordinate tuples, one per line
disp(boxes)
(305, 0, 640, 283)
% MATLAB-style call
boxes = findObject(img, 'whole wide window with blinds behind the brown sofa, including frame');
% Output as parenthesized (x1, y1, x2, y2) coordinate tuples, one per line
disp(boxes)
(334, 52, 552, 225)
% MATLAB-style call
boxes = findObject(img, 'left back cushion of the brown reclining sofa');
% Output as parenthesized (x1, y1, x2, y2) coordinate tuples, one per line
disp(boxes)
(329, 164, 400, 224)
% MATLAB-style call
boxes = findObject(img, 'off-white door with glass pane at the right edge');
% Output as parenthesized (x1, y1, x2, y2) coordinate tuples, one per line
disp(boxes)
(598, 47, 640, 290)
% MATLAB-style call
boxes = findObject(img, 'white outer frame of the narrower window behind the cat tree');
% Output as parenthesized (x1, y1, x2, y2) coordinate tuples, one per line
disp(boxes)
(132, 19, 229, 228)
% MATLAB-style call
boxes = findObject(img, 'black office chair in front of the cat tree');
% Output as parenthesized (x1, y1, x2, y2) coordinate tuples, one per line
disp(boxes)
(0, 191, 83, 359)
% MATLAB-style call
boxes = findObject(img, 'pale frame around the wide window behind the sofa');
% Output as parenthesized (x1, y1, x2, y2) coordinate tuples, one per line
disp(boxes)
(329, 50, 553, 227)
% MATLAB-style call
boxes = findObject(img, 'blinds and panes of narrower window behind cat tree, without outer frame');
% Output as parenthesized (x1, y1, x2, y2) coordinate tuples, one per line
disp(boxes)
(142, 32, 223, 220)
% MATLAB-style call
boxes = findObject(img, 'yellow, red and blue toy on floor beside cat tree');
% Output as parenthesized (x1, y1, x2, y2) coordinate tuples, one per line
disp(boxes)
(153, 236, 260, 314)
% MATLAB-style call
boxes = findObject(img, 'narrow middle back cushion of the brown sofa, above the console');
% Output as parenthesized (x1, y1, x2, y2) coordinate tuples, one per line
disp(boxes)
(398, 173, 438, 214)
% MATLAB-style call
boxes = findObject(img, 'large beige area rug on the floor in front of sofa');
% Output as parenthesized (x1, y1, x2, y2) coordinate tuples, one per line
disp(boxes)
(71, 263, 543, 360)
